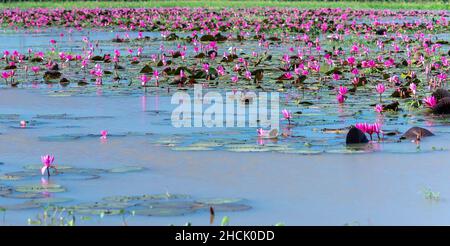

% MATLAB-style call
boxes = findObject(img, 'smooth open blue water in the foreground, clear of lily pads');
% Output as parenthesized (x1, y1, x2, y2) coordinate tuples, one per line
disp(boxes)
(0, 89, 450, 225)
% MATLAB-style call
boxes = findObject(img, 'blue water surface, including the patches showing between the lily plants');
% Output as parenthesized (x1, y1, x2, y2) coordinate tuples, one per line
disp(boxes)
(0, 22, 450, 225)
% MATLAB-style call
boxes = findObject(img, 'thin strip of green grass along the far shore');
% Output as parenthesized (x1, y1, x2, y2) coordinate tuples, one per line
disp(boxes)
(0, 0, 449, 10)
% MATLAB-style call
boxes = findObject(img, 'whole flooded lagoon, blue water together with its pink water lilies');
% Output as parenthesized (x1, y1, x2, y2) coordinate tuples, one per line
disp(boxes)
(0, 9, 450, 225)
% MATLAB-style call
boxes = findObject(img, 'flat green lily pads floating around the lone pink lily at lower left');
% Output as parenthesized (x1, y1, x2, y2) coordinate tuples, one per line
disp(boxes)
(0, 165, 251, 219)
